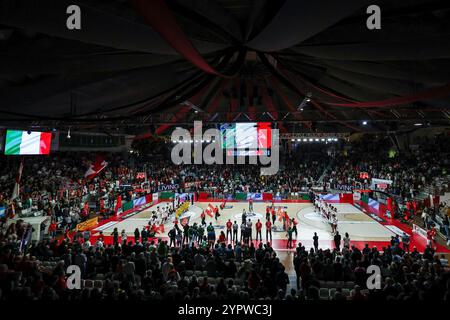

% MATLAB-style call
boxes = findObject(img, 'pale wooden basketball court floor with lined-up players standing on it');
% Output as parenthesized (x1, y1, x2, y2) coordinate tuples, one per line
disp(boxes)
(92, 201, 446, 252)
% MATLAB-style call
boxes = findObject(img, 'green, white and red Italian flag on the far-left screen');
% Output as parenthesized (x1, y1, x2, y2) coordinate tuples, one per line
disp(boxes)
(5, 130, 52, 155)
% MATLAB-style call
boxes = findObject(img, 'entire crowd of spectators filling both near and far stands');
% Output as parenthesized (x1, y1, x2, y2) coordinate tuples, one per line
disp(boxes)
(0, 134, 450, 301)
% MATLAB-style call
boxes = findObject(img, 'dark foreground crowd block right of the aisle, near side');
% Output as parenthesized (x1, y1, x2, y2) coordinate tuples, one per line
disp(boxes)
(294, 240, 450, 302)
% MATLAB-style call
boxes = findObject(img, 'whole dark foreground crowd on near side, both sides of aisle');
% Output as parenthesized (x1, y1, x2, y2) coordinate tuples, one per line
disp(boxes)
(0, 234, 450, 301)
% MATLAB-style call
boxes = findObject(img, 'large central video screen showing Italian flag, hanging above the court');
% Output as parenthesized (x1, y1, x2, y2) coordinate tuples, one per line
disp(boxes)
(220, 122, 272, 150)
